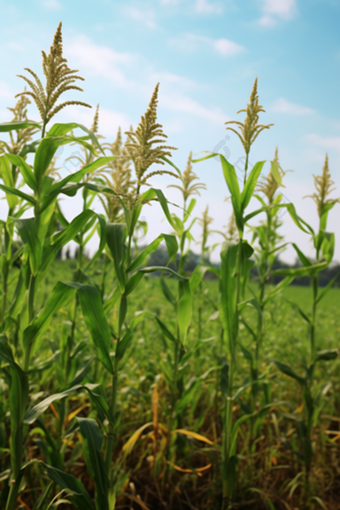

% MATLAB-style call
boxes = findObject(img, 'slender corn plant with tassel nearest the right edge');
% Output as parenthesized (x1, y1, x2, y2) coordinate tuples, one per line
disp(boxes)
(274, 155, 339, 496)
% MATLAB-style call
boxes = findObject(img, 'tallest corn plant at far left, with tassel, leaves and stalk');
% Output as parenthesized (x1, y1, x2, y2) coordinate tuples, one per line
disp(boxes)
(0, 26, 114, 510)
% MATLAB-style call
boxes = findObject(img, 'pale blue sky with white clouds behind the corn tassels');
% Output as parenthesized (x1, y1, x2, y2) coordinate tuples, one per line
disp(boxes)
(0, 0, 340, 260)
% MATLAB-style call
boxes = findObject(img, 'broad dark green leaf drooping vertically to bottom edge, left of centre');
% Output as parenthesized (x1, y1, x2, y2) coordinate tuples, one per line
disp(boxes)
(76, 418, 109, 510)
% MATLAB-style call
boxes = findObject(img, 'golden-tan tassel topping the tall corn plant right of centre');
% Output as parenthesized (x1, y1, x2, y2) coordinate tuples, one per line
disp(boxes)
(225, 78, 274, 155)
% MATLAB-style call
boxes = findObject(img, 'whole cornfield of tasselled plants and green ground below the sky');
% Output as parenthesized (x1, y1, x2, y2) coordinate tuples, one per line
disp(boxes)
(0, 24, 340, 510)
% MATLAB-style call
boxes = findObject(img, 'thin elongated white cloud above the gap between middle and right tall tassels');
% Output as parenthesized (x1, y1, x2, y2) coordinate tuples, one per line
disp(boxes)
(170, 33, 245, 57)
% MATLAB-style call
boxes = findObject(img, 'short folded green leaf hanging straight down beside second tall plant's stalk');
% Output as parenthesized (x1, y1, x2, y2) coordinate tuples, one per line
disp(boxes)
(106, 223, 126, 293)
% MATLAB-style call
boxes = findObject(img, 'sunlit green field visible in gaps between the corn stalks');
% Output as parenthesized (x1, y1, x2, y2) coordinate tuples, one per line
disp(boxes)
(1, 260, 340, 508)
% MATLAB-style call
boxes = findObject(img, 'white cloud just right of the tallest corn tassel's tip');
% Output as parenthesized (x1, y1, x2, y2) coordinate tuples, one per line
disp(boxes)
(67, 35, 134, 87)
